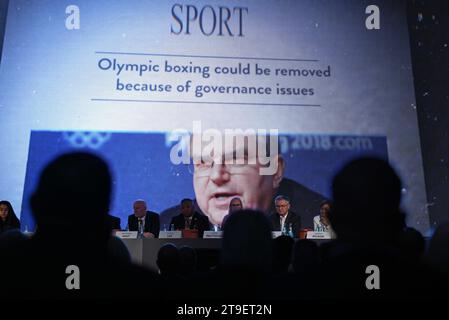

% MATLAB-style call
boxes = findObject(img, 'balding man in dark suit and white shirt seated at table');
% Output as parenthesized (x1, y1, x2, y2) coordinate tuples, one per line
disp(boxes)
(128, 200, 160, 238)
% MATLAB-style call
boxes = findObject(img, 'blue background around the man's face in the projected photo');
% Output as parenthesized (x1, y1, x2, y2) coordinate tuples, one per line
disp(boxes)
(22, 131, 387, 230)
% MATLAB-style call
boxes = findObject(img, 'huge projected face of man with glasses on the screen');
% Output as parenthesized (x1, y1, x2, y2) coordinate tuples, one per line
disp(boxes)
(193, 140, 284, 225)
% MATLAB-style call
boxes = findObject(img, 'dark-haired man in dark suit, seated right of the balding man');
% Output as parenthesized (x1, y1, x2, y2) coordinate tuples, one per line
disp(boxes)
(170, 199, 210, 238)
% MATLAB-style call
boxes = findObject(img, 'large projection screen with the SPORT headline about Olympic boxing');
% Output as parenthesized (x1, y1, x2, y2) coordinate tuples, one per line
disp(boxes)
(0, 0, 428, 231)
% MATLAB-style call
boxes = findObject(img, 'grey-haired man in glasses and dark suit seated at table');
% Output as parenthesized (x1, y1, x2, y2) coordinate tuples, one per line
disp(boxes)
(269, 195, 301, 238)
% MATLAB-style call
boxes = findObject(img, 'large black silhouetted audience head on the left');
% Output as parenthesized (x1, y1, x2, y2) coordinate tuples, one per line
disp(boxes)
(31, 152, 111, 242)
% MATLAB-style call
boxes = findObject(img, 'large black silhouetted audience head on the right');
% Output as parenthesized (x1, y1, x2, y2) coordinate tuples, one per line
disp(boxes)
(330, 158, 405, 242)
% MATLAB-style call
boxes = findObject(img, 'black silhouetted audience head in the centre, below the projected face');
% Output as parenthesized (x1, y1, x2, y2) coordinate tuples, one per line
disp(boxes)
(221, 210, 273, 273)
